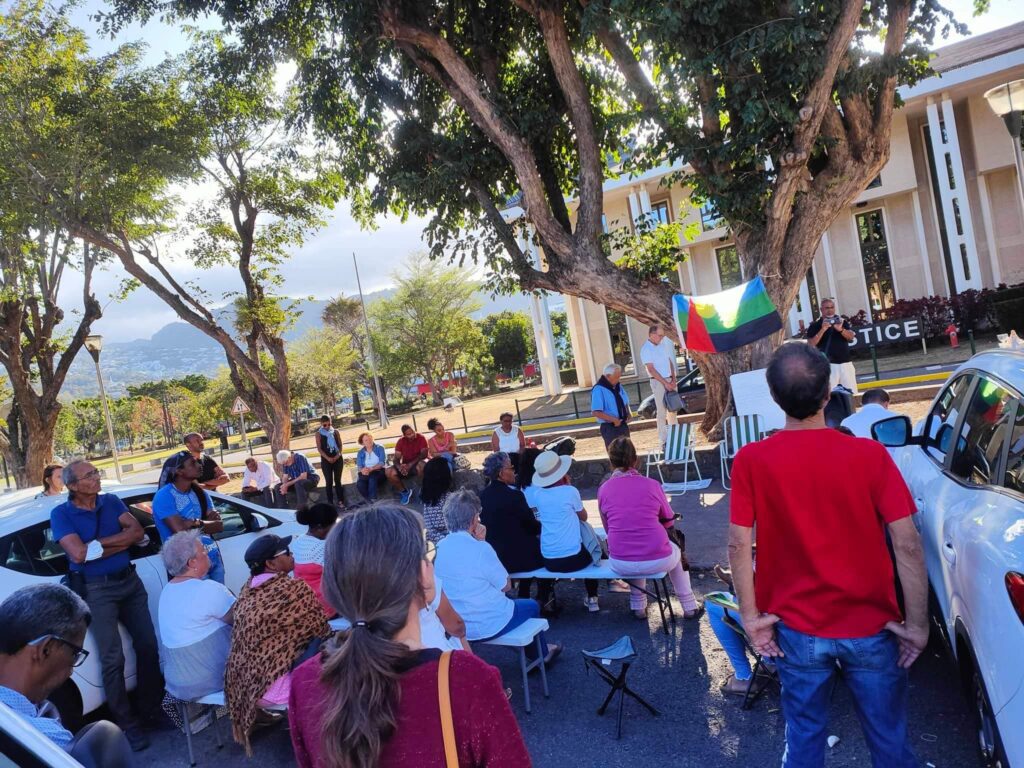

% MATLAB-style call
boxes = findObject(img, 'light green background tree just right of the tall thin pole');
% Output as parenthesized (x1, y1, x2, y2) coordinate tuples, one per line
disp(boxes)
(370, 258, 482, 404)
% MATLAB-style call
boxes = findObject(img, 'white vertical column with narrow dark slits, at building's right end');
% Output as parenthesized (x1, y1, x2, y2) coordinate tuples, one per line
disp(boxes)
(928, 93, 981, 293)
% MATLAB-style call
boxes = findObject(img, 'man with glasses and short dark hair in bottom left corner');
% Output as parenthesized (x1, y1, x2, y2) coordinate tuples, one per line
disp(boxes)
(0, 584, 132, 768)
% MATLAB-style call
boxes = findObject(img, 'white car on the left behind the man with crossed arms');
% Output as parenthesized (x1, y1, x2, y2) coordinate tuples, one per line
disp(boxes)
(0, 483, 305, 725)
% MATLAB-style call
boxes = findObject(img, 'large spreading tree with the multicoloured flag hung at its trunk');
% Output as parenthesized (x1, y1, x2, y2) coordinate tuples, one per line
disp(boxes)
(109, 0, 954, 431)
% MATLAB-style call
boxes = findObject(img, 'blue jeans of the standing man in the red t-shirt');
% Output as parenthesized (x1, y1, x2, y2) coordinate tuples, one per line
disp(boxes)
(775, 622, 918, 768)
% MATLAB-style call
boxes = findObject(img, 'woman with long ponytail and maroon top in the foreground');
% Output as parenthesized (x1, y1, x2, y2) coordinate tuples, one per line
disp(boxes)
(288, 502, 530, 768)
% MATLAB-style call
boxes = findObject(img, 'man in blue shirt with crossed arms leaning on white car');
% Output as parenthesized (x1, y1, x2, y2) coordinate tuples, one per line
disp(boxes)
(50, 461, 164, 752)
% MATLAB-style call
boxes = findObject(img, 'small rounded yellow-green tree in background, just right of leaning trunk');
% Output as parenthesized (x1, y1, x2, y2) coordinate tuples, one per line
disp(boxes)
(288, 328, 357, 415)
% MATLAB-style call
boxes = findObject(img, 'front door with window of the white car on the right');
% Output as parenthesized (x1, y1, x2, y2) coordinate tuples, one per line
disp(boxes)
(898, 372, 975, 632)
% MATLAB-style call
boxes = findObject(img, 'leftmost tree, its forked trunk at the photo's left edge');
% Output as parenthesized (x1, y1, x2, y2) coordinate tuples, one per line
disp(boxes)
(0, 3, 108, 487)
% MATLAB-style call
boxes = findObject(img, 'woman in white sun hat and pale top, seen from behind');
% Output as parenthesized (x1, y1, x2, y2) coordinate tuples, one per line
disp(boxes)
(532, 451, 600, 612)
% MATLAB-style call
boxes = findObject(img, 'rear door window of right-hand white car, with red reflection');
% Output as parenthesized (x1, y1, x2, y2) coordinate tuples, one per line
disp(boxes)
(949, 377, 1016, 485)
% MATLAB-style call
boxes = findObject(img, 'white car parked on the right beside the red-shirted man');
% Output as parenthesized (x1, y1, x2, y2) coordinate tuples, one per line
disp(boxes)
(874, 351, 1024, 768)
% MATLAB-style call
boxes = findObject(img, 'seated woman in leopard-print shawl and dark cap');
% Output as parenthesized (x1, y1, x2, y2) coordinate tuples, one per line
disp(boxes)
(224, 534, 333, 757)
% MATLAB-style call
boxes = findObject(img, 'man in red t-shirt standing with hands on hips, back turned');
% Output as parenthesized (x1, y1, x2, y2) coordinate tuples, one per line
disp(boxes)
(729, 343, 928, 768)
